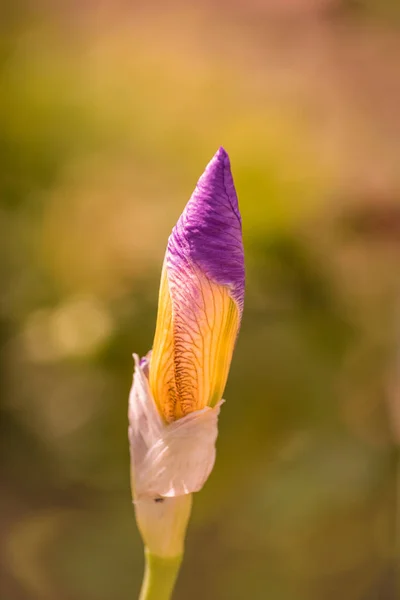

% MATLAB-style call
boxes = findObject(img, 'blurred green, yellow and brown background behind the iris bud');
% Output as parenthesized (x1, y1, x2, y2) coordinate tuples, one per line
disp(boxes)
(0, 0, 400, 600)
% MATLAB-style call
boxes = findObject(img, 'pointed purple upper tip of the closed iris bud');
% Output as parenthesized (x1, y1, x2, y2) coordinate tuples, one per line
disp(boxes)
(167, 146, 245, 310)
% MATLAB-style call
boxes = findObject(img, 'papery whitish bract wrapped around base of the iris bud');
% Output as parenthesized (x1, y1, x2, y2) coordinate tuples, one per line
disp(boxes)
(128, 354, 223, 504)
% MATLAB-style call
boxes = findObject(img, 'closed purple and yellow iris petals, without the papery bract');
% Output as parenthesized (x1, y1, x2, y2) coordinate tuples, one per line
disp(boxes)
(150, 148, 244, 423)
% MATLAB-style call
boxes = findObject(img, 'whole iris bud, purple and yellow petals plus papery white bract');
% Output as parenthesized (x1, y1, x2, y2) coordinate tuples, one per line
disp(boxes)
(129, 148, 245, 499)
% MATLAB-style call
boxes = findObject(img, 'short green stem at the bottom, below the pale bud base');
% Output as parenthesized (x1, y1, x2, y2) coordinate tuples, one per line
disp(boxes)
(139, 548, 182, 600)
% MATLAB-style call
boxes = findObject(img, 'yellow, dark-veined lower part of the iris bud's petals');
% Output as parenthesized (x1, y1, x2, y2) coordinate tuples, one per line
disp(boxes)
(150, 265, 240, 422)
